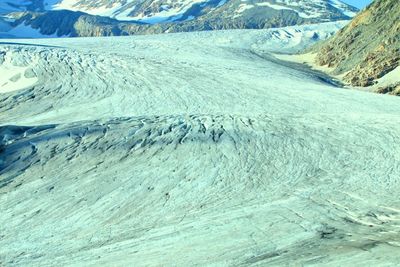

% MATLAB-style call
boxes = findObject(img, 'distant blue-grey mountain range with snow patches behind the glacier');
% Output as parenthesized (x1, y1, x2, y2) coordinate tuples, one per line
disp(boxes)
(0, 0, 358, 37)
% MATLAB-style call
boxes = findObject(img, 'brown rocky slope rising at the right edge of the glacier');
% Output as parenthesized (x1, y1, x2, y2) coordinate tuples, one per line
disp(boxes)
(314, 0, 400, 95)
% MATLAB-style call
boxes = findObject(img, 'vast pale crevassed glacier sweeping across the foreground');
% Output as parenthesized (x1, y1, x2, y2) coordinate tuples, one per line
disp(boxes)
(0, 23, 400, 266)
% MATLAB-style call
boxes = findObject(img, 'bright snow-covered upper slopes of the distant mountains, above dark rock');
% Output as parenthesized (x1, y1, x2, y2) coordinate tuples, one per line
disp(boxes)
(37, 0, 357, 23)
